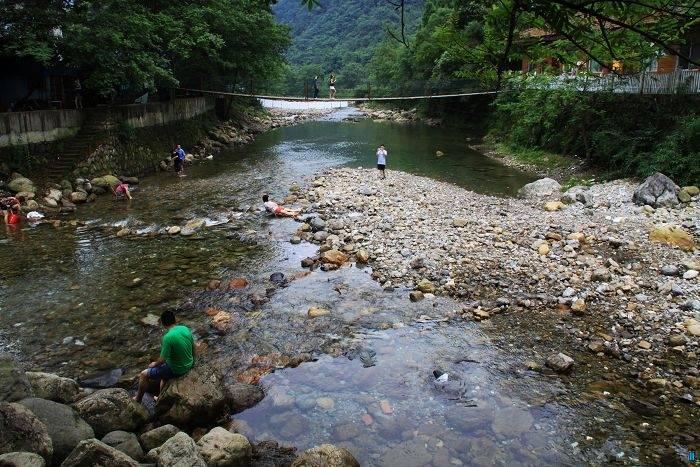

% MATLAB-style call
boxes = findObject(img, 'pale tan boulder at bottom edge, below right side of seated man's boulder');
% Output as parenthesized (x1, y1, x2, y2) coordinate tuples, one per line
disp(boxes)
(197, 427, 253, 467)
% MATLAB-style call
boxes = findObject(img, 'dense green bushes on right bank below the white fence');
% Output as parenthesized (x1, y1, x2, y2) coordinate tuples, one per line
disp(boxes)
(489, 89, 700, 184)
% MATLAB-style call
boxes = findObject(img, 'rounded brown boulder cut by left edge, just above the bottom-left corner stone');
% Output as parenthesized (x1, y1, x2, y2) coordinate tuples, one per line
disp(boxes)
(0, 402, 53, 463)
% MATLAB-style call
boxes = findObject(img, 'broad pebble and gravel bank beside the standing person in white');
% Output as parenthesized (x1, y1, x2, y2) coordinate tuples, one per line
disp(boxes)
(298, 169, 700, 394)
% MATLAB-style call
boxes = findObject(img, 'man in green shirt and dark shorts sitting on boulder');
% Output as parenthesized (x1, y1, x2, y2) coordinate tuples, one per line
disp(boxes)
(134, 310, 195, 402)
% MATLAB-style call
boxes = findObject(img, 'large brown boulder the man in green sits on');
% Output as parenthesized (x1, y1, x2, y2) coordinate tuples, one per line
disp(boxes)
(156, 365, 229, 427)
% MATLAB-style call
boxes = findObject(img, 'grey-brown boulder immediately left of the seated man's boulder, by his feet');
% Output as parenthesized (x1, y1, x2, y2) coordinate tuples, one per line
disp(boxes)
(75, 388, 148, 437)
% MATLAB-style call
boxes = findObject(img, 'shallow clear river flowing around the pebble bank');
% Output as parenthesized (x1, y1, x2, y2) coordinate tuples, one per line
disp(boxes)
(0, 110, 688, 466)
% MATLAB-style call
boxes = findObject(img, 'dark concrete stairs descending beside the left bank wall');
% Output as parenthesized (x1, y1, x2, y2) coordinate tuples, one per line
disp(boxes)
(42, 108, 113, 182)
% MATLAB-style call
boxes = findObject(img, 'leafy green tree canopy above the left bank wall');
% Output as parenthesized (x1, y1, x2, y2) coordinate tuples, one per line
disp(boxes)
(0, 0, 289, 97)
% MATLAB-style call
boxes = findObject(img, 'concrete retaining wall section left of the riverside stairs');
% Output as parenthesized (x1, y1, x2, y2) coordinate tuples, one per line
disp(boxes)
(0, 109, 83, 147)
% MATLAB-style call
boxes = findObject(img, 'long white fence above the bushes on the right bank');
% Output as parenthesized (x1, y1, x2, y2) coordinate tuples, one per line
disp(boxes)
(513, 70, 700, 94)
